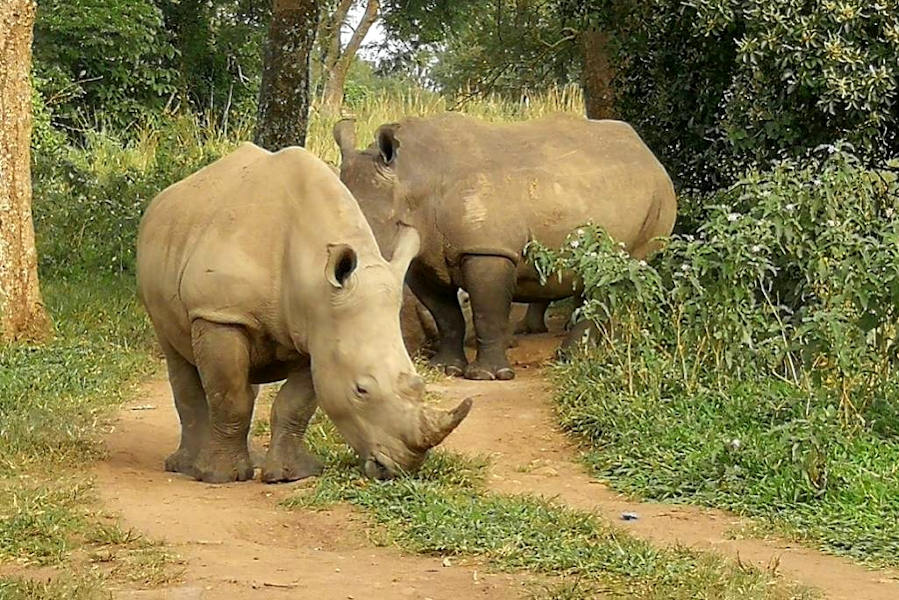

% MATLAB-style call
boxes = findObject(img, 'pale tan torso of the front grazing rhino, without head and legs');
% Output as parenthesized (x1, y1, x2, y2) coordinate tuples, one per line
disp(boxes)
(138, 144, 377, 355)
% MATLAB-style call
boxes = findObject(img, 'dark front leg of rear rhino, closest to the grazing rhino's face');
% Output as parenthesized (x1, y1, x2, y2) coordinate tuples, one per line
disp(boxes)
(407, 264, 468, 376)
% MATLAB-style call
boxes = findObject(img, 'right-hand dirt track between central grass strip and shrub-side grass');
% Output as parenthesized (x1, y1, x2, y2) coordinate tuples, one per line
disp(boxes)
(431, 334, 899, 600)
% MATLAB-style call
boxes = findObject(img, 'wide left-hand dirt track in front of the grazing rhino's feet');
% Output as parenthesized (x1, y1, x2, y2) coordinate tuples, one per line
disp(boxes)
(95, 381, 524, 600)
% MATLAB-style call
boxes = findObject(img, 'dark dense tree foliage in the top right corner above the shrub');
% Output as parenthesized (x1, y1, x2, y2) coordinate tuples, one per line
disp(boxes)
(585, 0, 899, 189)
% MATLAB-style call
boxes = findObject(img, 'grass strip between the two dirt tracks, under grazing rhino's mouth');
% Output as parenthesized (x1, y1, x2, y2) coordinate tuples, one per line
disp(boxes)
(287, 422, 813, 600)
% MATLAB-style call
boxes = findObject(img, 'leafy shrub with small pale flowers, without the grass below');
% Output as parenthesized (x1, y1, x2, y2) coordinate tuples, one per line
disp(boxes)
(536, 147, 899, 412)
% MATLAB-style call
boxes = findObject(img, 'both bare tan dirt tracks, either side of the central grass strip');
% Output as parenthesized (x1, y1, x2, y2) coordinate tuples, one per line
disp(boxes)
(96, 335, 899, 600)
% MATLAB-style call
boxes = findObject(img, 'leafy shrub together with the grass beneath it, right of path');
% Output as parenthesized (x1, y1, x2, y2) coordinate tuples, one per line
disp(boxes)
(531, 148, 899, 564)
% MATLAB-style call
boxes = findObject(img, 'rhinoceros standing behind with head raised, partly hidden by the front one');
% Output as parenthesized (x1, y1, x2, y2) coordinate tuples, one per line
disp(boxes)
(334, 114, 677, 379)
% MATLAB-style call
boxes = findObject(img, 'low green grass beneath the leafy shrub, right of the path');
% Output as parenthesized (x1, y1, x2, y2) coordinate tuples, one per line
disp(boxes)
(554, 356, 899, 566)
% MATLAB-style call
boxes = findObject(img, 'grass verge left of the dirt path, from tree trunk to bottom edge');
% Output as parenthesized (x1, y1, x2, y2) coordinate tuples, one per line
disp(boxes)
(0, 276, 179, 598)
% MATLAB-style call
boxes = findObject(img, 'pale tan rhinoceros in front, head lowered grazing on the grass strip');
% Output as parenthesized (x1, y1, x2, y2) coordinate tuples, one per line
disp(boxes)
(137, 144, 471, 482)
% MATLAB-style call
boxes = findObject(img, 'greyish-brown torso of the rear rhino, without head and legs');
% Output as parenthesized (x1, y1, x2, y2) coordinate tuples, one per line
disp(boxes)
(399, 115, 674, 262)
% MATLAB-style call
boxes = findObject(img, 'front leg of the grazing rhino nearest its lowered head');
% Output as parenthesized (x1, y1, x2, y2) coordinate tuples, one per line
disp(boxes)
(262, 366, 322, 483)
